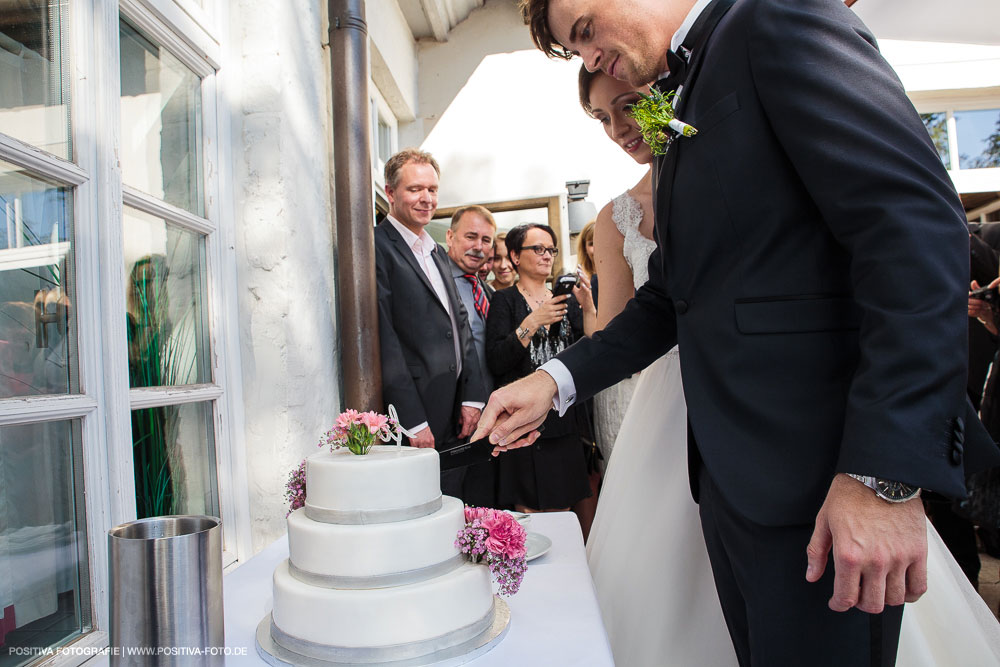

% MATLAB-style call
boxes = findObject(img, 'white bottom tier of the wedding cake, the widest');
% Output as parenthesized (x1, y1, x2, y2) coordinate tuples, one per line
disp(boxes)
(272, 561, 493, 652)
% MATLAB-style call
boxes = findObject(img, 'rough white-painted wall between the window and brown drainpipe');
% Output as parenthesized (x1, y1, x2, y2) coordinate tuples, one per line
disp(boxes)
(227, 0, 340, 552)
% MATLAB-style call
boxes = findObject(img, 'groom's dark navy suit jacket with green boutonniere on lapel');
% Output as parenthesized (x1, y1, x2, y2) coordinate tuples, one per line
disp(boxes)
(559, 0, 1000, 525)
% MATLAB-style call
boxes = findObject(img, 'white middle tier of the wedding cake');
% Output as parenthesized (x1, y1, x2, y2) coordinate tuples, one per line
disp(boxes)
(288, 496, 465, 588)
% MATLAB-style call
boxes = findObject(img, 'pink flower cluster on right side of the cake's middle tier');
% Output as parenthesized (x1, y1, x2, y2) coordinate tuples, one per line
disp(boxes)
(455, 507, 528, 595)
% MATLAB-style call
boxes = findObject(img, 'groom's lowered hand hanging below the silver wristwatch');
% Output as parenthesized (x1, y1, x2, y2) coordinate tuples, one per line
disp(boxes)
(806, 474, 927, 614)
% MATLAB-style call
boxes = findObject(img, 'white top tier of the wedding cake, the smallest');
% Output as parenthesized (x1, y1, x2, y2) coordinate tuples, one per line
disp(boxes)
(306, 445, 441, 522)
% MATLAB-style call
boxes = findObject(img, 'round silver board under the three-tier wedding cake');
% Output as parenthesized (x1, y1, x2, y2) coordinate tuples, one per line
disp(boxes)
(257, 595, 510, 667)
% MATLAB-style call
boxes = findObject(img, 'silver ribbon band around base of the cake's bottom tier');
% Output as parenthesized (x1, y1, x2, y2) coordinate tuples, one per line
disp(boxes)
(271, 603, 496, 665)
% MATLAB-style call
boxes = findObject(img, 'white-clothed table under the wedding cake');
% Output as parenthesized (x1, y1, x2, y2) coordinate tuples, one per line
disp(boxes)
(223, 512, 614, 667)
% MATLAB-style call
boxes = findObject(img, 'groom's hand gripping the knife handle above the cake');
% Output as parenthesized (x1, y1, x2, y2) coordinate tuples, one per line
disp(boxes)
(472, 371, 558, 455)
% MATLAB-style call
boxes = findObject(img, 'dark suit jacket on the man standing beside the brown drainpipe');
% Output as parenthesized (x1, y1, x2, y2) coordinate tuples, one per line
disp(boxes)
(375, 219, 487, 449)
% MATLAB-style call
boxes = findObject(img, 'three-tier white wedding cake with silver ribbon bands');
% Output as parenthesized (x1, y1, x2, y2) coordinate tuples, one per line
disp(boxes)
(258, 446, 508, 665)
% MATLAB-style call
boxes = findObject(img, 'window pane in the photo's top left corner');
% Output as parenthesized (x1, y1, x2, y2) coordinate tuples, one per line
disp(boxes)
(0, 0, 72, 160)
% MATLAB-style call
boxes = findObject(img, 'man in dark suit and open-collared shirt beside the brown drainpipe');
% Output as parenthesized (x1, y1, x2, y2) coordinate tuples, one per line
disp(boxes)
(375, 149, 487, 497)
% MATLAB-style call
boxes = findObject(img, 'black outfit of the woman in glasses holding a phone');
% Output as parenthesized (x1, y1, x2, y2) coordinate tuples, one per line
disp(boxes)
(486, 286, 593, 509)
